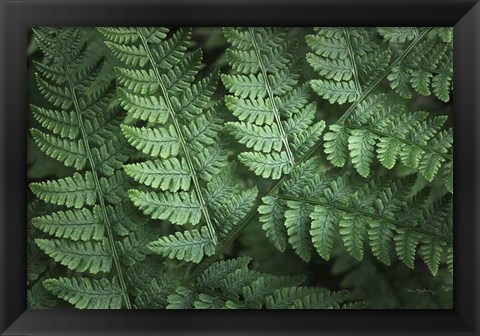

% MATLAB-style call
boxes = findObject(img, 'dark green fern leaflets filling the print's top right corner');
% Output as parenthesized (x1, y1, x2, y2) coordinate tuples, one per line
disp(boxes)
(378, 27, 453, 102)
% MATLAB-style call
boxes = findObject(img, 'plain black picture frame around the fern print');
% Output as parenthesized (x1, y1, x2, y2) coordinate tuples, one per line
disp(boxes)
(0, 0, 480, 335)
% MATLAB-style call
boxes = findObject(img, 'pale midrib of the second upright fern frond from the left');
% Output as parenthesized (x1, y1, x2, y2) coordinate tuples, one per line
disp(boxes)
(136, 28, 218, 245)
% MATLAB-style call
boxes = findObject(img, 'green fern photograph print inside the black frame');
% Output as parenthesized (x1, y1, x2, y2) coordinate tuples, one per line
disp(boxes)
(26, 27, 454, 309)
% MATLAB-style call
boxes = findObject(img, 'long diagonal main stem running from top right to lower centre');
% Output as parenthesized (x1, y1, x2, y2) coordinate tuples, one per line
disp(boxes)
(186, 27, 432, 283)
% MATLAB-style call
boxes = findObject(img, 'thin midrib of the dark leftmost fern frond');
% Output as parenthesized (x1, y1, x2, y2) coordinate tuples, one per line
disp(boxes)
(58, 40, 132, 309)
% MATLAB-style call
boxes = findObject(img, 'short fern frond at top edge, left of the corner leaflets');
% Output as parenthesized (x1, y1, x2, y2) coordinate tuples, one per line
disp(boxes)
(306, 28, 391, 104)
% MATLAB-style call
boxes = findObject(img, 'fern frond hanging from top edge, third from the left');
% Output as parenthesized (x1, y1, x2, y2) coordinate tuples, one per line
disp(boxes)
(222, 28, 325, 179)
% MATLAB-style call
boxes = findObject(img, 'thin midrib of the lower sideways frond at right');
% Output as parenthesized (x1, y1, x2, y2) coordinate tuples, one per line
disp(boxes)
(279, 195, 453, 245)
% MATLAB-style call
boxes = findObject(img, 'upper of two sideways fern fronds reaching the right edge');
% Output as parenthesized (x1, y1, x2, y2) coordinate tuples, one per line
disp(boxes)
(324, 95, 453, 192)
